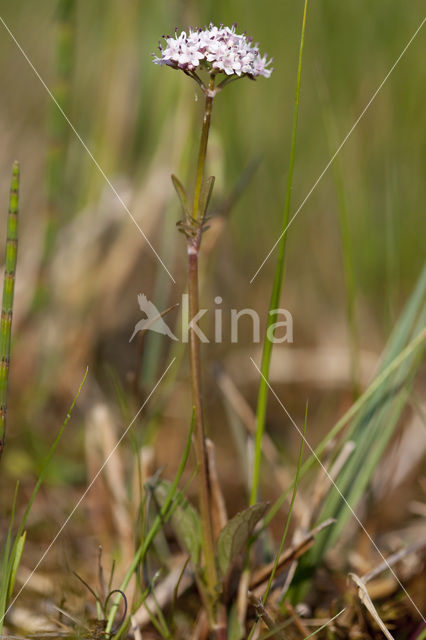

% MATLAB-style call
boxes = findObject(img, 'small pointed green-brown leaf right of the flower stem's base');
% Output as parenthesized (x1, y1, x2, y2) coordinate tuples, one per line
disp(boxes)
(217, 502, 268, 578)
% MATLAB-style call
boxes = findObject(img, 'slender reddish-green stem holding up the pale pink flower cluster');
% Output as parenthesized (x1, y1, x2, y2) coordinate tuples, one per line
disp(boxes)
(187, 75, 218, 601)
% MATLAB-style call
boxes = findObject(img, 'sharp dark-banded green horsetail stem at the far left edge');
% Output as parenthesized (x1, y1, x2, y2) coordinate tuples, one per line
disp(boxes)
(0, 162, 19, 457)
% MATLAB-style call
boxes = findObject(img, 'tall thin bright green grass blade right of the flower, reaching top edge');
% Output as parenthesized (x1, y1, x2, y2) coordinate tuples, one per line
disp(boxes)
(250, 0, 308, 505)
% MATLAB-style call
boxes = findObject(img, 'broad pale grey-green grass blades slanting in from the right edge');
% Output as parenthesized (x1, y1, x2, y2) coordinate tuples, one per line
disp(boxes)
(288, 267, 426, 588)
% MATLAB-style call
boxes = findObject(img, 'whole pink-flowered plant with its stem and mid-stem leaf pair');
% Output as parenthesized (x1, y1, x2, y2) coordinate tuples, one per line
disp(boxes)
(154, 24, 272, 637)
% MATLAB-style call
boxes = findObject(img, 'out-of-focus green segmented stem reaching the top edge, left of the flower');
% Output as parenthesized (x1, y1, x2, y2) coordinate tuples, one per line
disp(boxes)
(33, 0, 75, 310)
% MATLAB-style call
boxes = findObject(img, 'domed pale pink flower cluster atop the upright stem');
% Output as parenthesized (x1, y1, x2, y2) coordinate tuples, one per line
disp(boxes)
(154, 23, 273, 78)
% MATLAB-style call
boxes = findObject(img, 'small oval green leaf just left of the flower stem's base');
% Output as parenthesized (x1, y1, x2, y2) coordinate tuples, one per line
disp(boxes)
(154, 480, 201, 567)
